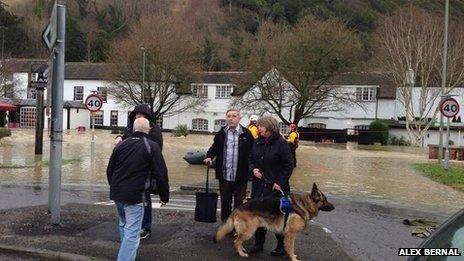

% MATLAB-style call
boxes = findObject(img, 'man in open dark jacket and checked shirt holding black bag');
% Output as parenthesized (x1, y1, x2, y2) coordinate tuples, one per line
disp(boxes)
(204, 109, 254, 221)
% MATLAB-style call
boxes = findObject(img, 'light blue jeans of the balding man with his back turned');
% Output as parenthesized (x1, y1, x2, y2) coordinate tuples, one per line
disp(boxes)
(115, 201, 143, 261)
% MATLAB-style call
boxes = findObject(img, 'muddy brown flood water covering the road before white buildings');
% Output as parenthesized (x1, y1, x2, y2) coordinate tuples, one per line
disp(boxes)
(0, 129, 464, 213)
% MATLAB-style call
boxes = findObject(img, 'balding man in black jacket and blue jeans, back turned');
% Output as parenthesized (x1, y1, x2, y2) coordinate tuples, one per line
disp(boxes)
(106, 118, 169, 260)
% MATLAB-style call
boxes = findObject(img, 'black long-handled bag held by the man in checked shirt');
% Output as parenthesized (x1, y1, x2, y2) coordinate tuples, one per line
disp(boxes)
(195, 165, 218, 223)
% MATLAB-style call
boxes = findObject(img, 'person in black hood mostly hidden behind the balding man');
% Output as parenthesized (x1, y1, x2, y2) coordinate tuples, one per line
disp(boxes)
(115, 104, 163, 239)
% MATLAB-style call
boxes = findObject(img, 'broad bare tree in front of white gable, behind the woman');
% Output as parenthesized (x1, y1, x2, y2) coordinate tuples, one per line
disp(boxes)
(235, 17, 361, 124)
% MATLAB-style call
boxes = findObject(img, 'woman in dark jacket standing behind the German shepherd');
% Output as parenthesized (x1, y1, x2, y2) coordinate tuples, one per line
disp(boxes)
(249, 116, 293, 256)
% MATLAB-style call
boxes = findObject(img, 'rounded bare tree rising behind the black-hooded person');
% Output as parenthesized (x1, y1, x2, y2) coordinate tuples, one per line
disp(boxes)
(107, 15, 200, 117)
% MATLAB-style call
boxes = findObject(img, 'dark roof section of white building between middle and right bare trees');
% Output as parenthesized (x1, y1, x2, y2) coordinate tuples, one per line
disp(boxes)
(330, 73, 396, 99)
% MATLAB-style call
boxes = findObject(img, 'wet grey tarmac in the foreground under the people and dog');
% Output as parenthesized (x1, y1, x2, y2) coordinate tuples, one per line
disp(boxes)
(0, 185, 449, 260)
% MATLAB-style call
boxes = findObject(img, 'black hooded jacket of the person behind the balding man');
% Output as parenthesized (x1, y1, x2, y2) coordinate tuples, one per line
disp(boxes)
(122, 104, 163, 150)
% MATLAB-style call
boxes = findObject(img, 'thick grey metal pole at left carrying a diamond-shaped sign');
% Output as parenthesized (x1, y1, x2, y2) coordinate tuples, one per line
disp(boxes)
(49, 2, 66, 225)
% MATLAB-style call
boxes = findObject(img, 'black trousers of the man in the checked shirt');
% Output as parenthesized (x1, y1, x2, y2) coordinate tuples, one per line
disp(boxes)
(219, 180, 247, 221)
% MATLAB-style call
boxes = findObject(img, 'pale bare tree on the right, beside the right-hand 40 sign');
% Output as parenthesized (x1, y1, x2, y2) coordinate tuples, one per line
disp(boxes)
(376, 7, 464, 145)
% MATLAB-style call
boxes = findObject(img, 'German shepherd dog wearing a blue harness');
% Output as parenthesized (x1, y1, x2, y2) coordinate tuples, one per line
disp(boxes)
(214, 183, 334, 261)
